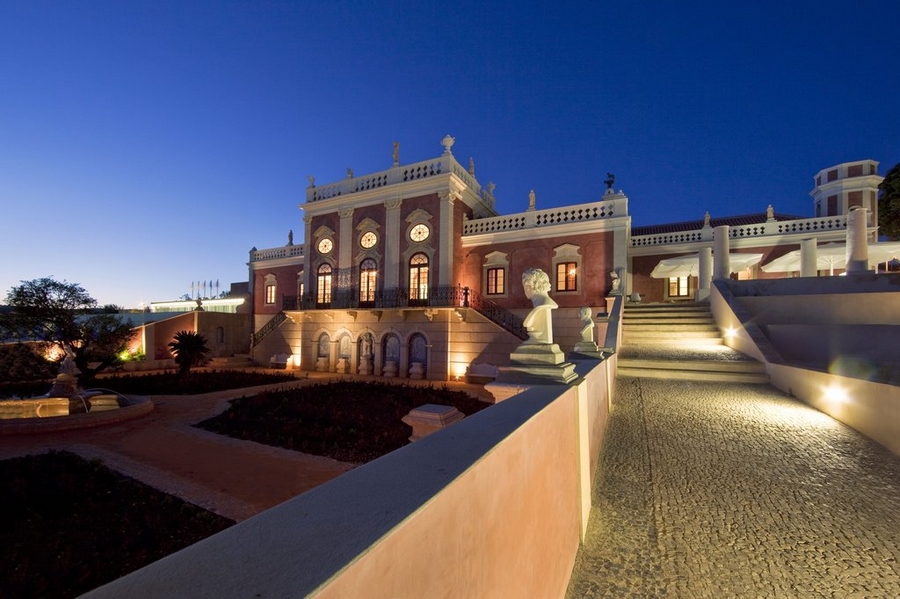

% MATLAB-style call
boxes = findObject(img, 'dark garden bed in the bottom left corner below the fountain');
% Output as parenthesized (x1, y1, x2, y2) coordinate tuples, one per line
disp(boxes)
(0, 452, 234, 598)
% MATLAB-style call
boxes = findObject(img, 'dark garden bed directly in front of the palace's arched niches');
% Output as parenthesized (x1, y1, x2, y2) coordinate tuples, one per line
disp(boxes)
(197, 382, 489, 463)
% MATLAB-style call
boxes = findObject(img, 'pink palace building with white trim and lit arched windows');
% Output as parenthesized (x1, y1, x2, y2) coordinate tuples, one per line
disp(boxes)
(248, 136, 882, 381)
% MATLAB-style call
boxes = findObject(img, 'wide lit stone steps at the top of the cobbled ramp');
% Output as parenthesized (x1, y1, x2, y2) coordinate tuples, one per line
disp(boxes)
(618, 303, 769, 384)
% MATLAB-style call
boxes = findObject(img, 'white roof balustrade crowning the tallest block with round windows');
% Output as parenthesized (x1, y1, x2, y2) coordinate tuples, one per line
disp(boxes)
(306, 154, 494, 212)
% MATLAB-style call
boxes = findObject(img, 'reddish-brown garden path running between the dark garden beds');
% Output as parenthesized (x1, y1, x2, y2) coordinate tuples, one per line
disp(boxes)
(0, 373, 492, 521)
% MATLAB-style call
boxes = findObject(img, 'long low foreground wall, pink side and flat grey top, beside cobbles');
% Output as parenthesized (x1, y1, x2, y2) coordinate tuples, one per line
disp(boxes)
(87, 360, 614, 599)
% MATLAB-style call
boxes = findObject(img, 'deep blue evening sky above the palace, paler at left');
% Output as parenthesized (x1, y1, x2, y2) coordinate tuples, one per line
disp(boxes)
(0, 0, 900, 307)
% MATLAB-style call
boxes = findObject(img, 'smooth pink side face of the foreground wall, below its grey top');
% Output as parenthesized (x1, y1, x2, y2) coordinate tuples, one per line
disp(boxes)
(316, 388, 580, 599)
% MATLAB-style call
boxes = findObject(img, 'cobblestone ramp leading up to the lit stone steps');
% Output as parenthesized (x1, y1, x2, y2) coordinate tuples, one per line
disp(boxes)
(568, 377, 900, 599)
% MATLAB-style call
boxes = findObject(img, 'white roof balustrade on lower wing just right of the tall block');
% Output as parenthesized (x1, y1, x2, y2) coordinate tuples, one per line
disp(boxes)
(463, 198, 628, 235)
